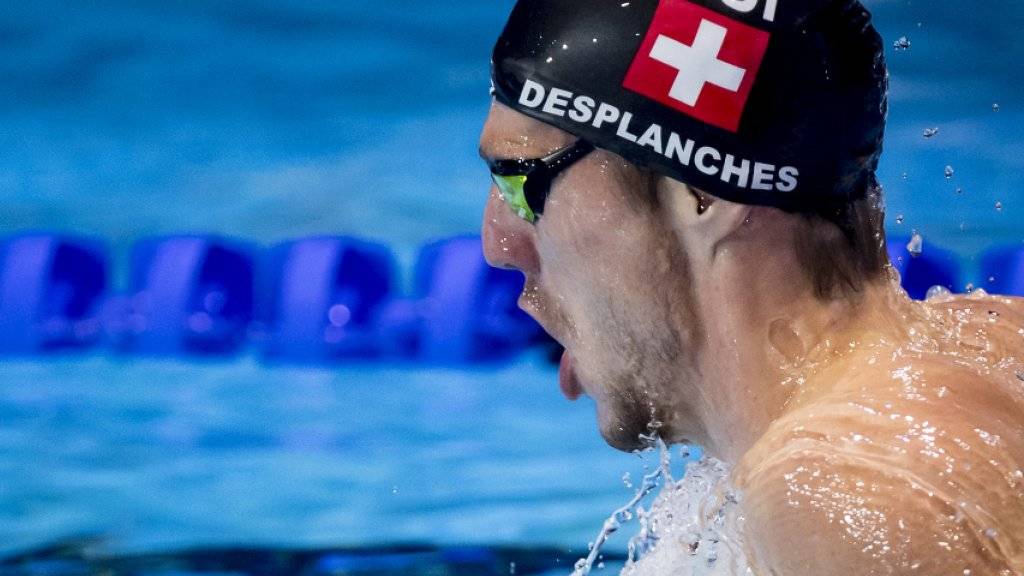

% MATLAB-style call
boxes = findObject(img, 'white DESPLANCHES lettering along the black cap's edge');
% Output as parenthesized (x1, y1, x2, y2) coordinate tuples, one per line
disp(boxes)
(519, 79, 800, 193)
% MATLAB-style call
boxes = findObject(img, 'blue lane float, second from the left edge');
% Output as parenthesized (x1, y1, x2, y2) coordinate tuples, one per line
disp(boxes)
(121, 236, 254, 355)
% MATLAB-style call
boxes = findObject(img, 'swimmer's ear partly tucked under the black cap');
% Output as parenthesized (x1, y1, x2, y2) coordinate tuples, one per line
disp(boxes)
(657, 177, 753, 257)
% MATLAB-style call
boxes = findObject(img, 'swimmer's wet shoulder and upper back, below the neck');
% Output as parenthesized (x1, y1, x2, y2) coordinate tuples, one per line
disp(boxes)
(735, 290, 1024, 575)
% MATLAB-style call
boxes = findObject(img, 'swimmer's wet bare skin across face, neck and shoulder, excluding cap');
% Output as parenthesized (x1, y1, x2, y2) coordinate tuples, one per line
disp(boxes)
(480, 104, 1024, 576)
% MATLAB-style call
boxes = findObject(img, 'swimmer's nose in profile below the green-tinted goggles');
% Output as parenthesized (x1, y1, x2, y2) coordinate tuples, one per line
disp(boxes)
(481, 187, 541, 276)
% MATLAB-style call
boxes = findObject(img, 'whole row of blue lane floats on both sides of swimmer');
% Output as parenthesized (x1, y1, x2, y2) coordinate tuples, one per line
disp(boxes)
(0, 227, 1011, 358)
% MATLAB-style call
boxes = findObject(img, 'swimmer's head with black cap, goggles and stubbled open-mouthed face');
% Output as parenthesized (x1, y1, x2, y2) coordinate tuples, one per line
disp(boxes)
(481, 0, 887, 449)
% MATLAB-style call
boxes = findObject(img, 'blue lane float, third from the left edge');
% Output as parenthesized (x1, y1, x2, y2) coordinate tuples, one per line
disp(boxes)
(258, 237, 395, 361)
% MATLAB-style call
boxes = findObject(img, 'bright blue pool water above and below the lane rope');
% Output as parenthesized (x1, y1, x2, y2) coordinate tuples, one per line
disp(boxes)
(0, 0, 1024, 551)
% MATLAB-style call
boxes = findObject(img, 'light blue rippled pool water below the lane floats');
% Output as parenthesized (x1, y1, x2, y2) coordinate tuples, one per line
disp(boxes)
(0, 356, 656, 554)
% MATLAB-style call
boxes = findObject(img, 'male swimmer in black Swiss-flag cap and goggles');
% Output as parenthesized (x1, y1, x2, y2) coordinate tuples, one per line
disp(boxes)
(480, 0, 1024, 576)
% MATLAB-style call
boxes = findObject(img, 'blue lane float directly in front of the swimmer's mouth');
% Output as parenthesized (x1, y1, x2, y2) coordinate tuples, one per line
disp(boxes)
(378, 231, 541, 364)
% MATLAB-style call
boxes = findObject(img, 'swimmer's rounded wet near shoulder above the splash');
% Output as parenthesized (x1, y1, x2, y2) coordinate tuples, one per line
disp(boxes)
(736, 361, 1024, 576)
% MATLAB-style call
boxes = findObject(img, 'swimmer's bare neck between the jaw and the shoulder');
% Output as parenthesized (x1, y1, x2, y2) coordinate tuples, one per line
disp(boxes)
(679, 266, 905, 463)
